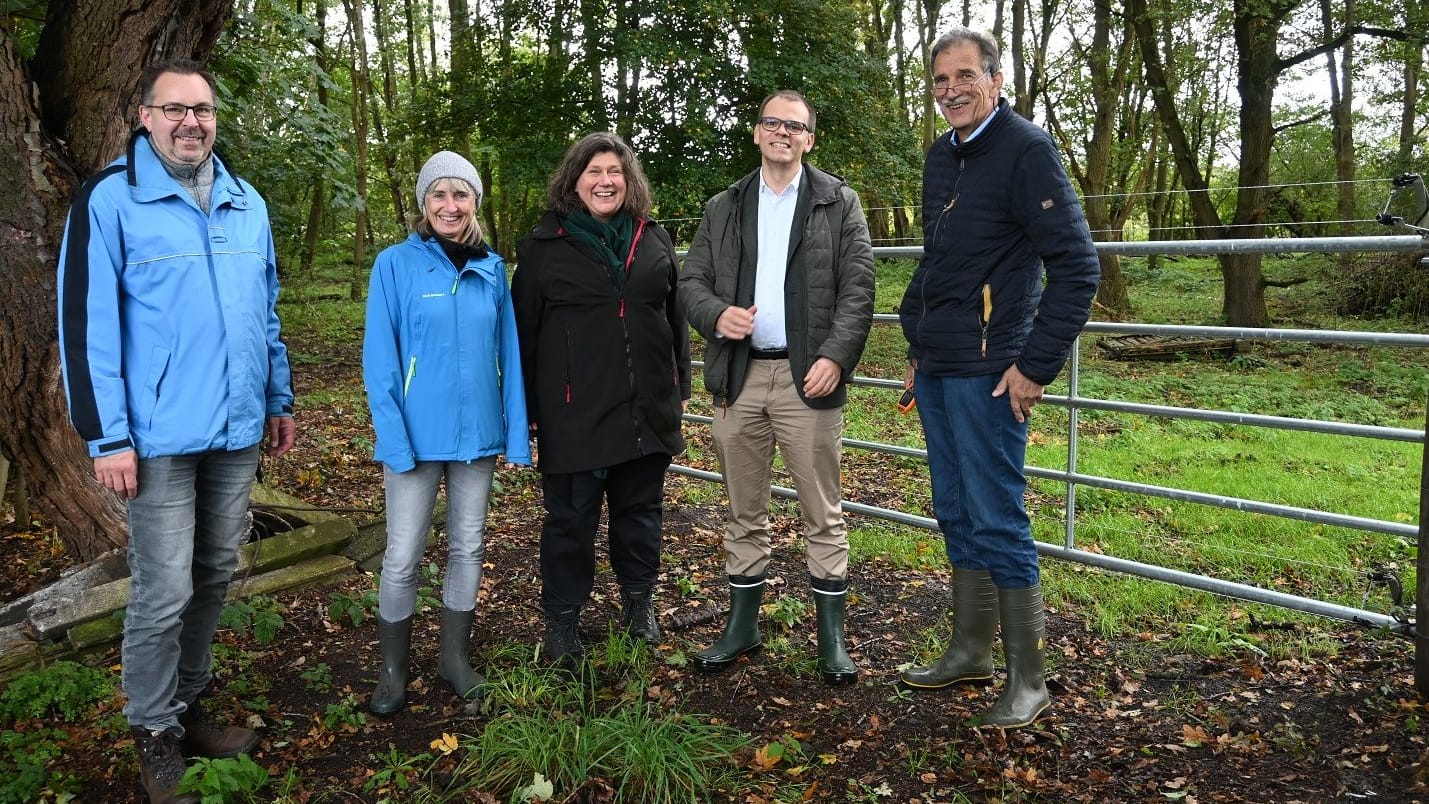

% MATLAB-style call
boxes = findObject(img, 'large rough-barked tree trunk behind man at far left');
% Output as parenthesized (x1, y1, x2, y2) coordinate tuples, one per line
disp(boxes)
(0, 0, 233, 560)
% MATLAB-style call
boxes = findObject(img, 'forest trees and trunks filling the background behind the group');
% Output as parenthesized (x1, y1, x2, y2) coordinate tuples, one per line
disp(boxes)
(0, 0, 1429, 659)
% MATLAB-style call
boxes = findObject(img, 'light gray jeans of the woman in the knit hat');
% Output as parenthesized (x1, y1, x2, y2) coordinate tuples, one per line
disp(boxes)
(377, 456, 496, 623)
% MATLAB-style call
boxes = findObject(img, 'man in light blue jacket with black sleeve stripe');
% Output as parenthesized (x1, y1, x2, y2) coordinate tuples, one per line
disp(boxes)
(59, 60, 296, 801)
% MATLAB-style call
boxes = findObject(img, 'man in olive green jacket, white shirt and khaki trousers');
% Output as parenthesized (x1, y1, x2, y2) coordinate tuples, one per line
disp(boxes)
(679, 90, 873, 684)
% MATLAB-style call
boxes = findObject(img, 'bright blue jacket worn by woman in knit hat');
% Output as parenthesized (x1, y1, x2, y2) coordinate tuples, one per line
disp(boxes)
(363, 234, 532, 471)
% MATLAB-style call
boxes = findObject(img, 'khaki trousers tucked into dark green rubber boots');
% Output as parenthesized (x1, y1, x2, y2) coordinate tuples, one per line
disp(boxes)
(712, 360, 849, 580)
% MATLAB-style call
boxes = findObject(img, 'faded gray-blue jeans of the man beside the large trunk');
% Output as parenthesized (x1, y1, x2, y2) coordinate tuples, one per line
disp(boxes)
(123, 446, 259, 730)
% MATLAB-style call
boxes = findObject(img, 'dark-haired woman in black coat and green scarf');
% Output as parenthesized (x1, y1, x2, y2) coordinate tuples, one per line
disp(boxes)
(512, 133, 690, 664)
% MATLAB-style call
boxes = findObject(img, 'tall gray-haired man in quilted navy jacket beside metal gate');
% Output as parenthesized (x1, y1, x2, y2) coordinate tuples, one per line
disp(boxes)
(899, 27, 1100, 728)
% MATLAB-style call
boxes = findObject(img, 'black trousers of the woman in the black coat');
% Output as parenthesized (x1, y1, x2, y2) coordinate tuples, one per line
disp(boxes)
(540, 454, 670, 610)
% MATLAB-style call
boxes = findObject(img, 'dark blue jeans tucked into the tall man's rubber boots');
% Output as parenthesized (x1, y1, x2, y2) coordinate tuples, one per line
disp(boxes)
(913, 371, 1039, 588)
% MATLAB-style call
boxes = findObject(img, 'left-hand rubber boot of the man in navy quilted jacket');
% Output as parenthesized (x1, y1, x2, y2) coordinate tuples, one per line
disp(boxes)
(899, 567, 997, 690)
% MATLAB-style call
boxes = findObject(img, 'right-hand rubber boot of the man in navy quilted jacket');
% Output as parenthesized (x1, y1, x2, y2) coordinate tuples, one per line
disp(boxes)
(976, 584, 1052, 728)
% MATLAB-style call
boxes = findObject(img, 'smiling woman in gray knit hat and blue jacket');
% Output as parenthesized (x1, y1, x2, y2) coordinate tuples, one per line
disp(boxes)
(363, 151, 532, 715)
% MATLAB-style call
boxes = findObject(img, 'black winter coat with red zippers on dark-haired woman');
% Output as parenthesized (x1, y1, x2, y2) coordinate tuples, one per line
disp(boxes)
(512, 211, 690, 474)
